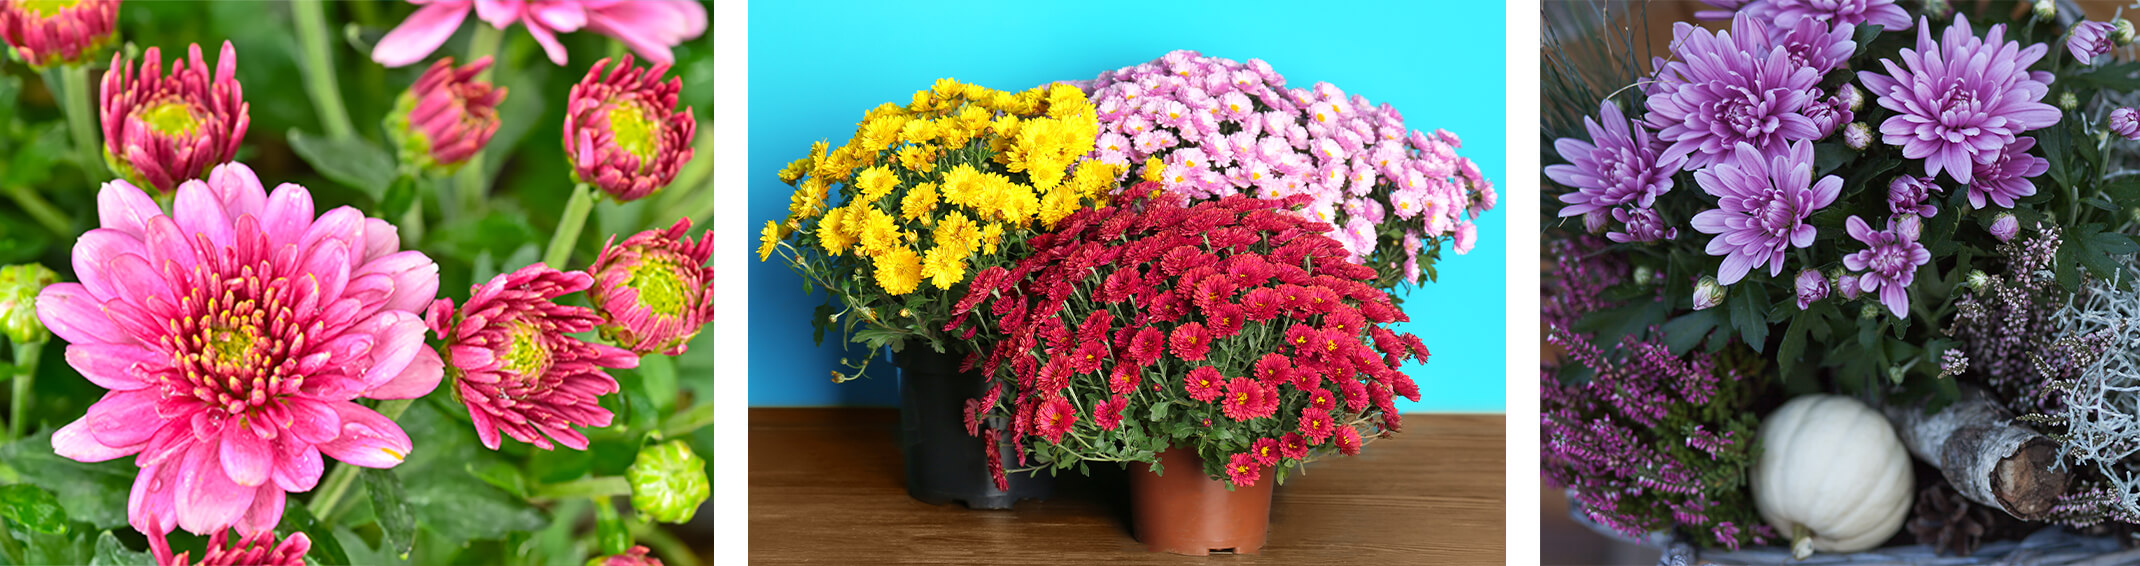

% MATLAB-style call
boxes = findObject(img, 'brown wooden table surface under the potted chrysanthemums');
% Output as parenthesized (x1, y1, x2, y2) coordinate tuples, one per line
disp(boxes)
(749, 407, 1507, 566)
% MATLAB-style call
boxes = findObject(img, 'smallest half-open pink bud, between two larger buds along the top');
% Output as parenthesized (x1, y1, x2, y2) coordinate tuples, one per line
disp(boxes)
(387, 56, 505, 174)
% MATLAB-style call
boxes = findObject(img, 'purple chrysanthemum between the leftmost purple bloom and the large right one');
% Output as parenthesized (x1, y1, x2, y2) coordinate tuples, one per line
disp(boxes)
(1646, 13, 1821, 169)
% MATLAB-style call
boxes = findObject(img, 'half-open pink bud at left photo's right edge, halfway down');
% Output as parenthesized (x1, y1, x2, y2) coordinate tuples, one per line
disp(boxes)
(586, 219, 713, 356)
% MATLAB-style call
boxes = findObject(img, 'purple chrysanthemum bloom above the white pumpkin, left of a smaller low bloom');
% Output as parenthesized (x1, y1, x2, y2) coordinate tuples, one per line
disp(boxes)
(1693, 142, 1843, 285)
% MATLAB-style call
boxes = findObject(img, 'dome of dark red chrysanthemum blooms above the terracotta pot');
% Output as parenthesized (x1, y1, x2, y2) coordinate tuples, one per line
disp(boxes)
(946, 191, 1427, 487)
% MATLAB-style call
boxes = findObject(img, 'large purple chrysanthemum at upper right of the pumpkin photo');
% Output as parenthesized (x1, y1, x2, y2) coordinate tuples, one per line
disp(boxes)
(1858, 15, 2059, 182)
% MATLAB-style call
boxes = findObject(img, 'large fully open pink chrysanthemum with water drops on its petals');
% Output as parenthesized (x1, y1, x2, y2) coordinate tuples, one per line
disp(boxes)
(36, 163, 441, 536)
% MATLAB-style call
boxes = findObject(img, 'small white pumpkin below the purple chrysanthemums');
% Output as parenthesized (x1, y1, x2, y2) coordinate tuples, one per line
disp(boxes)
(1753, 394, 1915, 560)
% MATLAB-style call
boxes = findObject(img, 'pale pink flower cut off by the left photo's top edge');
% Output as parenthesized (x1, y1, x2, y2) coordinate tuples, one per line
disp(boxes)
(372, 0, 706, 66)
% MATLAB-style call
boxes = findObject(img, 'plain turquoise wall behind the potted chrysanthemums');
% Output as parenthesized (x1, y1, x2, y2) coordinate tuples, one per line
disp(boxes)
(747, 0, 1530, 412)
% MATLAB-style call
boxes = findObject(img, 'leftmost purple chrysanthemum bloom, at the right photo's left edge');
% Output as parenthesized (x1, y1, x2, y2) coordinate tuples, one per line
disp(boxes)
(1545, 101, 1686, 217)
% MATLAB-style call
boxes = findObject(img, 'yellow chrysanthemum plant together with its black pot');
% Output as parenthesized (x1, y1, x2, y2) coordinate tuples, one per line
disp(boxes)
(758, 79, 1117, 508)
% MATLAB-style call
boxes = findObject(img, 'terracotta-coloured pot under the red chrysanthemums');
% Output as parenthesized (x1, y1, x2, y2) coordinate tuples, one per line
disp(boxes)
(1130, 448, 1273, 555)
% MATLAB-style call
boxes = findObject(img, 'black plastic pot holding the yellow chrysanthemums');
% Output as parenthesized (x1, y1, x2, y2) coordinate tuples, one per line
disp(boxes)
(895, 343, 1055, 508)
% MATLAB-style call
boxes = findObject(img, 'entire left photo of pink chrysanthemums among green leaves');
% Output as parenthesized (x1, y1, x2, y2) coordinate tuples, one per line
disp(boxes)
(0, 0, 715, 566)
